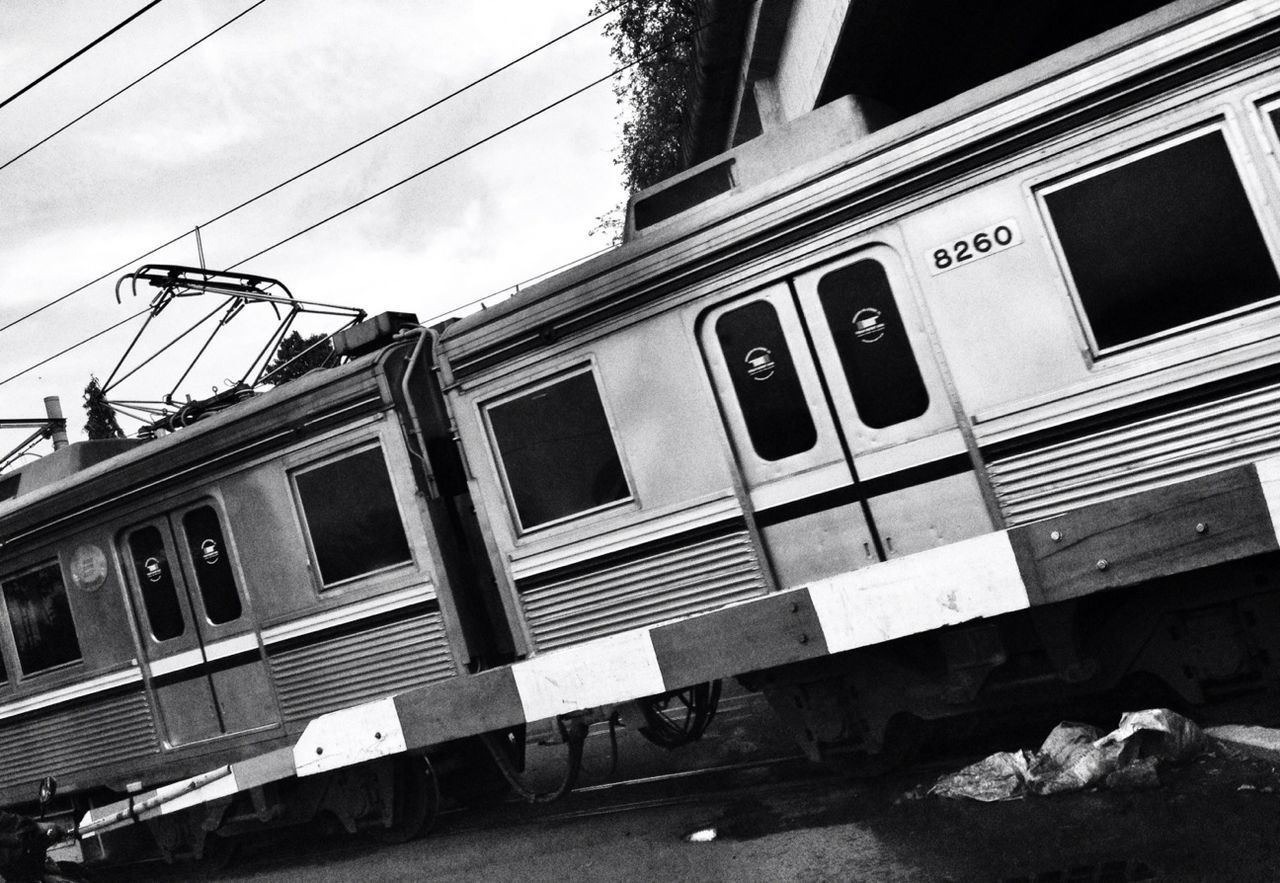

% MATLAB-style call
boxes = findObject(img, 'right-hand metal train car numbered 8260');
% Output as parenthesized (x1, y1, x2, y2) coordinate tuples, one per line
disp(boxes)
(440, 3, 1280, 756)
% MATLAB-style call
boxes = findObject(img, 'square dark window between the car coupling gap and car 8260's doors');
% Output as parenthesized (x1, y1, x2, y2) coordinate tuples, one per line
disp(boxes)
(489, 372, 630, 527)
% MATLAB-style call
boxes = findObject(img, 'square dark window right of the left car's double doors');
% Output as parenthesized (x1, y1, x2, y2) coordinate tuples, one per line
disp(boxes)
(296, 448, 411, 586)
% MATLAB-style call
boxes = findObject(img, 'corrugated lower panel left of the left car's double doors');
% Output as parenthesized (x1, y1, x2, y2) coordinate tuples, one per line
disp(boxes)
(0, 687, 160, 788)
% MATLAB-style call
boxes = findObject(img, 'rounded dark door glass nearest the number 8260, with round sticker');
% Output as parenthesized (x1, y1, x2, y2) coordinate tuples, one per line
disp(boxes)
(818, 261, 929, 429)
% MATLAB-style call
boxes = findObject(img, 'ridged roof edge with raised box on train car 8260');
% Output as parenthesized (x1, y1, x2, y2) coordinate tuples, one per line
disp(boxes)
(440, 0, 1249, 381)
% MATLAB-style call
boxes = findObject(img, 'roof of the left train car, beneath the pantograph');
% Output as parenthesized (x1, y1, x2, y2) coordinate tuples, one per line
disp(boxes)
(0, 342, 387, 553)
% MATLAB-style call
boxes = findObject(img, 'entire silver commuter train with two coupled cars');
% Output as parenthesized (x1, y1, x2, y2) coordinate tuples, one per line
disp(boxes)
(0, 0, 1280, 857)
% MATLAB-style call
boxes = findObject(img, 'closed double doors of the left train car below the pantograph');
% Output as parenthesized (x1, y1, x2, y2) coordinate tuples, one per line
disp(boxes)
(122, 502, 280, 746)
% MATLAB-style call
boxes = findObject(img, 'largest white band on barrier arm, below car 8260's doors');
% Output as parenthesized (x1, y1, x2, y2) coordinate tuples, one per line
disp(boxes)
(809, 522, 1030, 653)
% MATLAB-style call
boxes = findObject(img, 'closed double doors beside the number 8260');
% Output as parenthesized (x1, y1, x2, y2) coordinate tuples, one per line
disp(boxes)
(701, 240, 992, 585)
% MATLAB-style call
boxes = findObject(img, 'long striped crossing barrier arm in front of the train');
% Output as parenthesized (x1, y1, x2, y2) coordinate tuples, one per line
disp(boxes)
(72, 457, 1280, 832)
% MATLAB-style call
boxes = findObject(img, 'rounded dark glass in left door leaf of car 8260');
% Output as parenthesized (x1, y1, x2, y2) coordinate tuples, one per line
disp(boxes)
(716, 301, 818, 459)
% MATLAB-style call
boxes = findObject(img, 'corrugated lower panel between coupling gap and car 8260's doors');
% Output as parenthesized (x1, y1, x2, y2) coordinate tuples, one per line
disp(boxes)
(521, 531, 764, 650)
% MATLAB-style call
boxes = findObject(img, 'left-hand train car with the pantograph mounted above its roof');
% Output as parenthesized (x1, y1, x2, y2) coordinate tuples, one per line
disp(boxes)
(0, 308, 509, 852)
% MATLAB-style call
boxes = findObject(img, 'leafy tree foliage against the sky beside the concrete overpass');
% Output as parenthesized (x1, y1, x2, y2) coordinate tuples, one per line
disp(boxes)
(591, 0, 699, 195)
